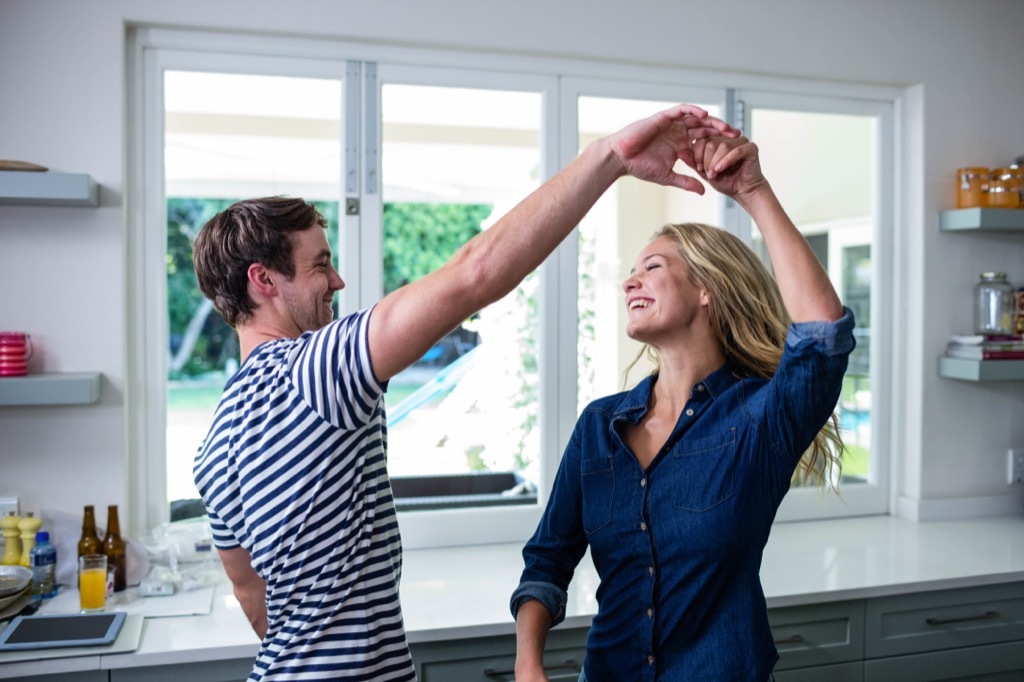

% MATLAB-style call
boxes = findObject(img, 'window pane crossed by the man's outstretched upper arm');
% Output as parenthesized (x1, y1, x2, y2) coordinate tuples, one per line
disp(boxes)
(381, 84, 542, 501)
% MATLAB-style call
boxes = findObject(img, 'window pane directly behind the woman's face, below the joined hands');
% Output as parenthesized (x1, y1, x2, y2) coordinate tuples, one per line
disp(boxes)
(577, 97, 720, 414)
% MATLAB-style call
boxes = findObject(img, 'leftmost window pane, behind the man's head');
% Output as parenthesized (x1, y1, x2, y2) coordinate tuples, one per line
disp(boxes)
(164, 72, 341, 512)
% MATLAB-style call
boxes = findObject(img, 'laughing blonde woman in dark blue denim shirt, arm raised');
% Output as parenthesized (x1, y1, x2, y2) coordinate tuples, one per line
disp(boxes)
(511, 135, 854, 682)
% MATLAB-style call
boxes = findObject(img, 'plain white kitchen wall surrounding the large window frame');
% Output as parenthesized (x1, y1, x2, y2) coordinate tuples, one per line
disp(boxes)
(0, 0, 1024, 532)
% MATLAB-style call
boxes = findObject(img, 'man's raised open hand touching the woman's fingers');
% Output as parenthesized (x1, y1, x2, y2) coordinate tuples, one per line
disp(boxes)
(606, 104, 739, 195)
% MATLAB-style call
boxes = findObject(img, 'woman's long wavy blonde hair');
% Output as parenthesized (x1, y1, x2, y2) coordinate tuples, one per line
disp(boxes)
(627, 222, 843, 486)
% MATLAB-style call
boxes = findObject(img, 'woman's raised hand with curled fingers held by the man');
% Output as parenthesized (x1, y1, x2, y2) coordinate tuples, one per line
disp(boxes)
(684, 131, 768, 206)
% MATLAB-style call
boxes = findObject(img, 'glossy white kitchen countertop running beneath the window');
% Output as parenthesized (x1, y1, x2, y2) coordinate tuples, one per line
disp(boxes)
(0, 515, 1024, 679)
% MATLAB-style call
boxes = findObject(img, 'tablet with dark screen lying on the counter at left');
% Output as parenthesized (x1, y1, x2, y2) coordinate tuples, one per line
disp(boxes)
(0, 611, 125, 651)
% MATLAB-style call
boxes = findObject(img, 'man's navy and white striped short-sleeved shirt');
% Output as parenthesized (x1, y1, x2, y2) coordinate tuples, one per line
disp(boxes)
(194, 310, 416, 681)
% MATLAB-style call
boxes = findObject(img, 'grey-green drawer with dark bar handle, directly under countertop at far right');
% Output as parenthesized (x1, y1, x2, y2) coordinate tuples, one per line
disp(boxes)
(864, 583, 1024, 658)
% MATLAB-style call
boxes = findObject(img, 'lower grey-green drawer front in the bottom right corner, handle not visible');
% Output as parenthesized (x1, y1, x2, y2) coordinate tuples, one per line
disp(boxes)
(864, 642, 1024, 682)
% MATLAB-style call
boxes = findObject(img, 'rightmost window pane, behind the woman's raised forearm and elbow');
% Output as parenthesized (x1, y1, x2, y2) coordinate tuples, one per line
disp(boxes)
(751, 108, 879, 483)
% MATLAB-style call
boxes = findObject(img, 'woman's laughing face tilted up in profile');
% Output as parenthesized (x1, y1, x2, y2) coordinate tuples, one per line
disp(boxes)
(623, 237, 709, 347)
